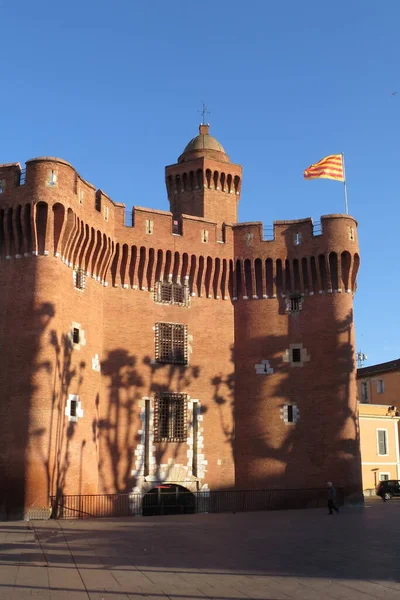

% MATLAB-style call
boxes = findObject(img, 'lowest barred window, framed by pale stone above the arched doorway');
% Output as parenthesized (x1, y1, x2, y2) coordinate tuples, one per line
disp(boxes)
(154, 392, 187, 442)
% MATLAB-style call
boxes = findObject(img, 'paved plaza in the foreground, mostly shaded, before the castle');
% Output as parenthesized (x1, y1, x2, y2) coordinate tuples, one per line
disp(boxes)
(0, 500, 400, 600)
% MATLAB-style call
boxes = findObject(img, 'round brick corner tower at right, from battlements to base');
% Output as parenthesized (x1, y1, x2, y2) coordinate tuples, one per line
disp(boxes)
(233, 215, 361, 495)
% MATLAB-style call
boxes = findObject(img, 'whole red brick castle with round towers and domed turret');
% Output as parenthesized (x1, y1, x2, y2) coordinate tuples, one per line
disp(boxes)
(0, 125, 361, 515)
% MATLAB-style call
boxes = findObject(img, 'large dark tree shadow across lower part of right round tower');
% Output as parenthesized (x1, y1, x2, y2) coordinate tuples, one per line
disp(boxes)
(211, 309, 360, 493)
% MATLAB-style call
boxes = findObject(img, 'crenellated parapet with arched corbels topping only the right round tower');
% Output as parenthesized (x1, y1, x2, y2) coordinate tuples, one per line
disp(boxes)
(233, 214, 360, 300)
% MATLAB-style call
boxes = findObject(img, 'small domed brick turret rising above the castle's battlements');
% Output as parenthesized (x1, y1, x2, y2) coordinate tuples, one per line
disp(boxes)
(165, 125, 242, 231)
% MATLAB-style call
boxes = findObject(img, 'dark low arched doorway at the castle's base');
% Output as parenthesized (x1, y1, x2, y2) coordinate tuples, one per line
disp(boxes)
(143, 483, 196, 517)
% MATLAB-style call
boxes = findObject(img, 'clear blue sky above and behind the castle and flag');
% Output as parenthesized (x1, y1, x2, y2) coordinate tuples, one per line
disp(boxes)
(0, 0, 400, 364)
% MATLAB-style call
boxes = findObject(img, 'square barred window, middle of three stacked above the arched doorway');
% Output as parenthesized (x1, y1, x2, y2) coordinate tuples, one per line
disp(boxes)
(156, 323, 188, 365)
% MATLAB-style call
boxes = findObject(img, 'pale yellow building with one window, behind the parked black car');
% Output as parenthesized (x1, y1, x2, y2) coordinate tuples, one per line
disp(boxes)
(359, 403, 400, 496)
